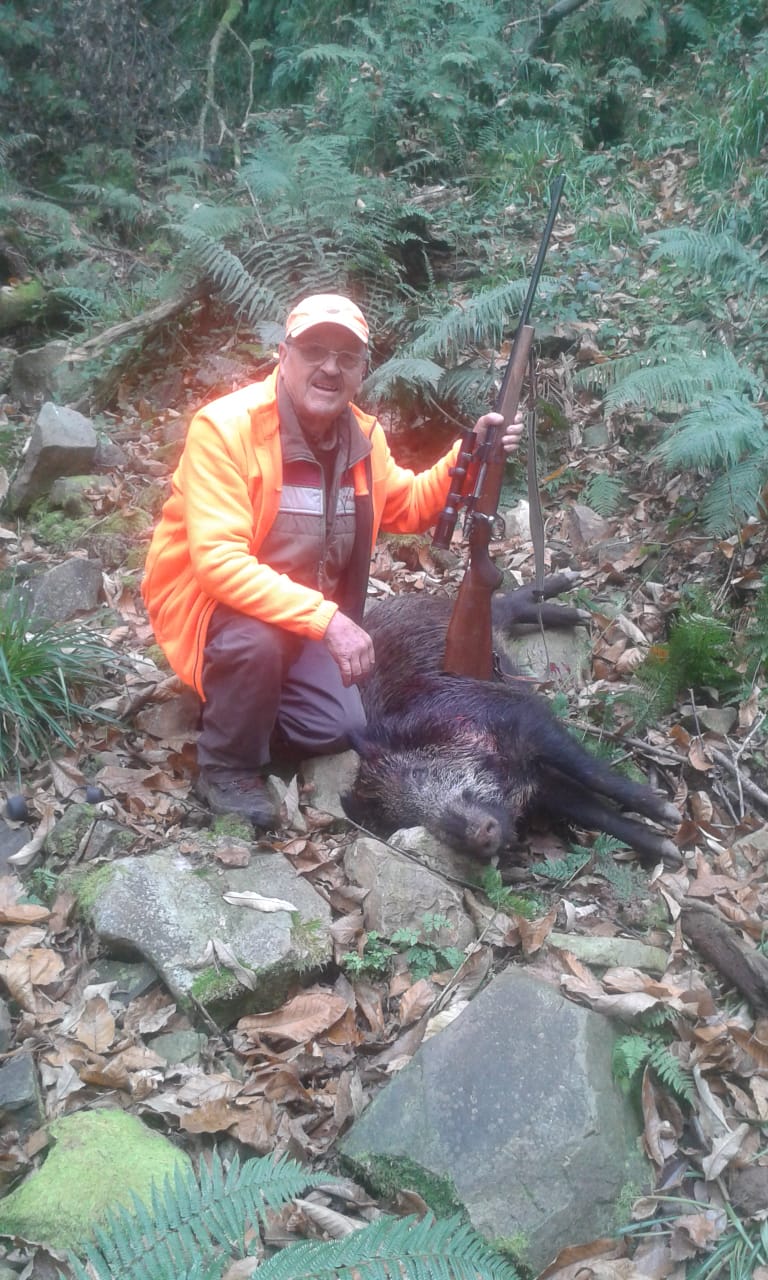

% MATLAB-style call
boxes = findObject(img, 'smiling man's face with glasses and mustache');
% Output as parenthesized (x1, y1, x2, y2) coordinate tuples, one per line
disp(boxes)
(279, 324, 366, 435)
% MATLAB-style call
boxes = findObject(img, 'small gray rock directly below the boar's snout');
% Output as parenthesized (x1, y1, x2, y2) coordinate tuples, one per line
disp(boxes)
(344, 837, 476, 947)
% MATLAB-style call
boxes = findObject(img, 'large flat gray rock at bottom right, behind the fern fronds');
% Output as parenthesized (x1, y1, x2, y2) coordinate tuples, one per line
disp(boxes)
(340, 968, 649, 1271)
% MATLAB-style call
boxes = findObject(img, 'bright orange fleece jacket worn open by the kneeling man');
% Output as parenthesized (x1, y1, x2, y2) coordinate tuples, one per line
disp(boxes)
(142, 370, 458, 696)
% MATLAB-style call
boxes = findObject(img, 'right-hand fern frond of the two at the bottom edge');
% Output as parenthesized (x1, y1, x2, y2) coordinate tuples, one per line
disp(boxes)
(259, 1217, 518, 1280)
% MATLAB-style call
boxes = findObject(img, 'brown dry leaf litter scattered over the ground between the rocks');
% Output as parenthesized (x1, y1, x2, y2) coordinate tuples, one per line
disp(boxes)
(0, 180, 768, 1280)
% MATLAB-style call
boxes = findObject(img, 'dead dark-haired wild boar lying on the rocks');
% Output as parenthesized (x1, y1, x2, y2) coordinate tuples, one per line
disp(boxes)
(342, 576, 680, 865)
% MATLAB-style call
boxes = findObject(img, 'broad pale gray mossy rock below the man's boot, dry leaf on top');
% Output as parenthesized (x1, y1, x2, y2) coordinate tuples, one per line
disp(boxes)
(83, 840, 332, 1023)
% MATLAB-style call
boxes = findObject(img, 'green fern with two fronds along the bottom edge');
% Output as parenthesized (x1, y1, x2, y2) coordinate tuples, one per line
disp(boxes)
(65, 1152, 518, 1280)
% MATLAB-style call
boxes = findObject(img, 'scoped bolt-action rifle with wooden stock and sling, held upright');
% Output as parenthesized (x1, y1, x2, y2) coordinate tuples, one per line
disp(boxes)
(433, 175, 566, 680)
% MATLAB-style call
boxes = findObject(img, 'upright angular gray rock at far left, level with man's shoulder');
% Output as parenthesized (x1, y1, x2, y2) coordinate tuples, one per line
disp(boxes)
(6, 402, 96, 513)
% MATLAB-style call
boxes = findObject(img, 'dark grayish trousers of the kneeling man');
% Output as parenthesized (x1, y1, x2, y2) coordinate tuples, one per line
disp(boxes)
(197, 604, 365, 772)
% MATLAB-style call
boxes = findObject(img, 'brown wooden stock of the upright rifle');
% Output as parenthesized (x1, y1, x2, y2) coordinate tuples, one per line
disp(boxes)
(443, 325, 534, 680)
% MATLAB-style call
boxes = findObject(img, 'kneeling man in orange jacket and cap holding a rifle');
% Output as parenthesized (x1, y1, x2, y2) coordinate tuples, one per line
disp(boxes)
(142, 294, 522, 827)
